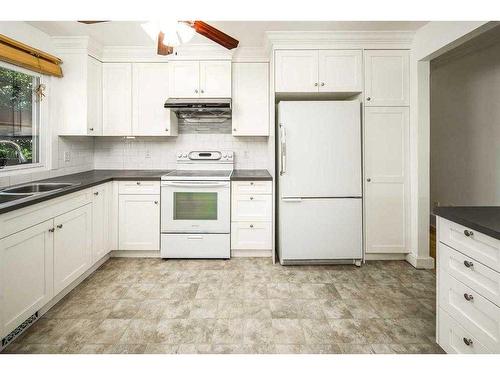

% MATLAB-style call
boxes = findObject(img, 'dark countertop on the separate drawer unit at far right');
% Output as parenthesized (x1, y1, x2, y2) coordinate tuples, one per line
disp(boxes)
(434, 206, 500, 240)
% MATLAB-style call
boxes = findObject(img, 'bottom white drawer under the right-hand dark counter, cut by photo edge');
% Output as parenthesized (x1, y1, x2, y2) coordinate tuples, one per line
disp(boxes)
(438, 309, 491, 354)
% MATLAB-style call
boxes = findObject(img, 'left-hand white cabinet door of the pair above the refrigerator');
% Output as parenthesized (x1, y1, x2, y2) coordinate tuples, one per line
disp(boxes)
(275, 50, 318, 92)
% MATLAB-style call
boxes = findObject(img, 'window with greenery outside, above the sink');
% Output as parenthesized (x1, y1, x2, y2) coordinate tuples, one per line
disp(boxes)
(0, 64, 41, 170)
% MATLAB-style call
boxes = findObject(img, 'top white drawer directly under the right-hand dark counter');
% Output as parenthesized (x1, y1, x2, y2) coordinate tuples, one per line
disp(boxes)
(438, 218, 500, 272)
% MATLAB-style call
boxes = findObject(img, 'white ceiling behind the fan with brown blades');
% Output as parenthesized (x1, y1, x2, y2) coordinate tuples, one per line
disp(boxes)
(28, 21, 427, 47)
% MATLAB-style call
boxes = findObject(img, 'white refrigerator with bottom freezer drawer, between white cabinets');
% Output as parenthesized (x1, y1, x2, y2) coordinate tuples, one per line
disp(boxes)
(278, 100, 363, 265)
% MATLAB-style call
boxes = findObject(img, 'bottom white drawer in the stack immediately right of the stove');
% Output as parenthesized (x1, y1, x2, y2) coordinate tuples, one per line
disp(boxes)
(231, 221, 272, 250)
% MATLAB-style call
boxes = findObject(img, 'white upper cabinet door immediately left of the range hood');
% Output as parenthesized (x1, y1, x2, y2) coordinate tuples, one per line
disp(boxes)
(132, 63, 177, 136)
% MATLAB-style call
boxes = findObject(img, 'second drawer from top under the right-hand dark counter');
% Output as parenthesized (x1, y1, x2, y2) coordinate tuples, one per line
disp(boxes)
(438, 243, 500, 306)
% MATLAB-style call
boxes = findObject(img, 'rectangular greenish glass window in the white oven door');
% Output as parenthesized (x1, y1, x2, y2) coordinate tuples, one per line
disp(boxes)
(174, 192, 217, 220)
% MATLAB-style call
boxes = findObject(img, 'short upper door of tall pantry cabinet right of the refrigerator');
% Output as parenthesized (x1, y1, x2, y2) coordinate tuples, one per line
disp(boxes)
(365, 50, 410, 107)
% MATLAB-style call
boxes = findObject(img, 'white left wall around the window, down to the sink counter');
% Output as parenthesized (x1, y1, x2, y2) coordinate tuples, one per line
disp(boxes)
(0, 21, 94, 187)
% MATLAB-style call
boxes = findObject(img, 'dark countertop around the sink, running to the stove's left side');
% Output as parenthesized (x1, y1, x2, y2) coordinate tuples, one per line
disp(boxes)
(0, 169, 171, 214)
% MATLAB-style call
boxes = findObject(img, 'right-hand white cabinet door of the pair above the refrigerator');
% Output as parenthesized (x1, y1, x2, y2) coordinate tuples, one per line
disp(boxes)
(318, 50, 363, 92)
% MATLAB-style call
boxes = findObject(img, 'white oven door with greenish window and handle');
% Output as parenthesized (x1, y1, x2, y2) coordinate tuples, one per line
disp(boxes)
(161, 181, 231, 233)
